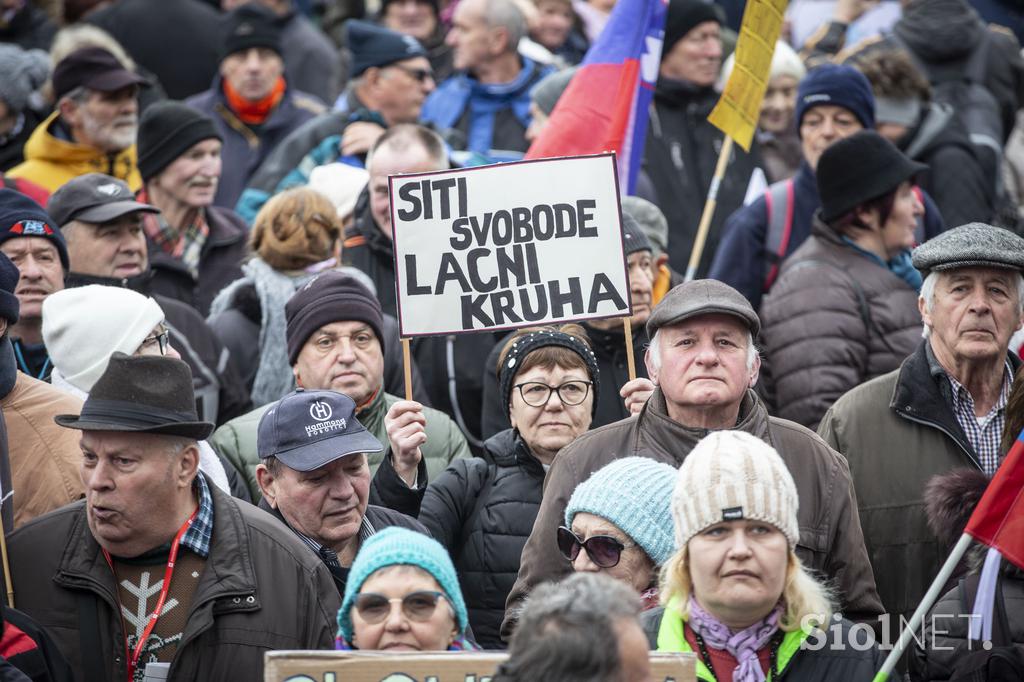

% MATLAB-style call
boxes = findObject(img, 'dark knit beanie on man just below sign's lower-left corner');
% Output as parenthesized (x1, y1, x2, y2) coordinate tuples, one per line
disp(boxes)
(285, 270, 384, 365)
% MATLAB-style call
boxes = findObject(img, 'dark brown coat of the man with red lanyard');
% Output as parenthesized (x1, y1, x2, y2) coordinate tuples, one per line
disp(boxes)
(8, 475, 341, 682)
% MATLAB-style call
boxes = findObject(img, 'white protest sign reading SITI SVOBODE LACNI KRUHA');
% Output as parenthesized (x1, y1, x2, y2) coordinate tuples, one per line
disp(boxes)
(389, 154, 632, 338)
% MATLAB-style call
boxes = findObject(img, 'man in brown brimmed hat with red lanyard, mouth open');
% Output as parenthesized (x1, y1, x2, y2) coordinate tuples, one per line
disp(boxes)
(8, 353, 340, 682)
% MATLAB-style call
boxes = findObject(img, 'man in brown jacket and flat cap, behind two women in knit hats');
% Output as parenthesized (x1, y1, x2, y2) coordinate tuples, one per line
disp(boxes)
(502, 280, 882, 636)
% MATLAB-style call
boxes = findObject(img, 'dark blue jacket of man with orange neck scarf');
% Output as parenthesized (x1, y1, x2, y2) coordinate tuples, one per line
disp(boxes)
(185, 76, 326, 209)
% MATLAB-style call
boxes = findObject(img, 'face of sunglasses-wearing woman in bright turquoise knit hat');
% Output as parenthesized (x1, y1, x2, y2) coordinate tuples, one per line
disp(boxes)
(351, 566, 458, 651)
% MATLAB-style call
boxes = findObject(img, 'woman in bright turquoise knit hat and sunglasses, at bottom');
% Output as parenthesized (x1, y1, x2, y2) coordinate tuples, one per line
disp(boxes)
(336, 526, 477, 652)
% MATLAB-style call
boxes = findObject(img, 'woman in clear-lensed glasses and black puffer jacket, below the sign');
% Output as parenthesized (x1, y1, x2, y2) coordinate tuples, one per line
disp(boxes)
(420, 325, 600, 648)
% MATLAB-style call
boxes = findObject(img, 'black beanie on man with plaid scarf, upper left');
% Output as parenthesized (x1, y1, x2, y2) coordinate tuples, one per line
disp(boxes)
(137, 101, 223, 182)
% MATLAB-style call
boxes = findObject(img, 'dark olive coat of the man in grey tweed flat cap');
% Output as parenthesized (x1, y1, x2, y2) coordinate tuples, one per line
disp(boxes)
(818, 341, 1020, 617)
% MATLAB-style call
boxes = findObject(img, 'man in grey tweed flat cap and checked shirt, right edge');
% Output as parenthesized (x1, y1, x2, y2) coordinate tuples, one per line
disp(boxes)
(818, 222, 1024, 630)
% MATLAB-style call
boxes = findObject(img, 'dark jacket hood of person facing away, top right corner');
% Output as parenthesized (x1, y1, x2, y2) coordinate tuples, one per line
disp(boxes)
(893, 0, 985, 61)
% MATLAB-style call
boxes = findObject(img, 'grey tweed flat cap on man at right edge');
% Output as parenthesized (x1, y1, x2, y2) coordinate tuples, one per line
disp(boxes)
(911, 222, 1024, 275)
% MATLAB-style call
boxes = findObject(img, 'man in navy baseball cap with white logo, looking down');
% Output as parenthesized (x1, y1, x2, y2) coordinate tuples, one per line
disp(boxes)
(256, 388, 430, 595)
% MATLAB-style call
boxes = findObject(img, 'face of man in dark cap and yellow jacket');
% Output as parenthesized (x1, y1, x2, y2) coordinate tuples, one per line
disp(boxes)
(65, 85, 138, 154)
